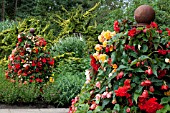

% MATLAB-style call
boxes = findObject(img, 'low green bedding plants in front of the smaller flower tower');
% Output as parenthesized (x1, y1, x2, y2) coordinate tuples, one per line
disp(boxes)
(0, 75, 40, 104)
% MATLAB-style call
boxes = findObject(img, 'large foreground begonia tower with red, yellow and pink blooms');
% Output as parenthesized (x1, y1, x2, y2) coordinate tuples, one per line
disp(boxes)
(69, 20, 170, 113)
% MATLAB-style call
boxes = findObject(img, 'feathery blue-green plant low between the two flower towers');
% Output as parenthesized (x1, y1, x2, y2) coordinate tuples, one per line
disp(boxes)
(42, 73, 84, 107)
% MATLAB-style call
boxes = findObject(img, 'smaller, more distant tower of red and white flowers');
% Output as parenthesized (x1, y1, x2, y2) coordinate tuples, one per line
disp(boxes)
(5, 30, 54, 84)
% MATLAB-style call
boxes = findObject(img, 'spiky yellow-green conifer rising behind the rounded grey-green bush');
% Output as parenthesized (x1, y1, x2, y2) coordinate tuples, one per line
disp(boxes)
(53, 3, 99, 52)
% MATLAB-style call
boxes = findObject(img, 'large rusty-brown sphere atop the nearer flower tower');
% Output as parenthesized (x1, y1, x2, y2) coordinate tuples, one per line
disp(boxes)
(134, 5, 155, 25)
